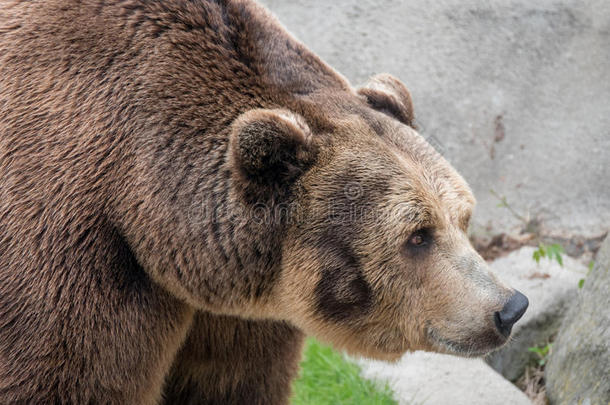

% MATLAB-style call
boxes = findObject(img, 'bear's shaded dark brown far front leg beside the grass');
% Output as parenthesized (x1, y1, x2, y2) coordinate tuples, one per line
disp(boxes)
(165, 313, 302, 405)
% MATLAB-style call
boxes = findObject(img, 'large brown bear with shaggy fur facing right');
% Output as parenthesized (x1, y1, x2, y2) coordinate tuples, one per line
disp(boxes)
(0, 0, 527, 404)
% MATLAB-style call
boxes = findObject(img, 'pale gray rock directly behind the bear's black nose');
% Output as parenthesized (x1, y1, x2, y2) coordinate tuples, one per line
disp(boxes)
(486, 246, 587, 381)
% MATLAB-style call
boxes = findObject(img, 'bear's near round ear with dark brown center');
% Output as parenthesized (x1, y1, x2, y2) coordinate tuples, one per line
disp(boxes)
(229, 109, 315, 194)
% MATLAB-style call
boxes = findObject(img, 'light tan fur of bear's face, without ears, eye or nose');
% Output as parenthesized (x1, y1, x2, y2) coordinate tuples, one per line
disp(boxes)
(279, 109, 511, 359)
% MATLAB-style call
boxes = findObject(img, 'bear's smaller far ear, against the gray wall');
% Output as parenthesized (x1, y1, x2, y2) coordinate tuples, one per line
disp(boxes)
(358, 73, 415, 127)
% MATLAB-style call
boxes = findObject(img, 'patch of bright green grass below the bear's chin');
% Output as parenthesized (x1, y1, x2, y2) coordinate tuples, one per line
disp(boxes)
(291, 339, 397, 405)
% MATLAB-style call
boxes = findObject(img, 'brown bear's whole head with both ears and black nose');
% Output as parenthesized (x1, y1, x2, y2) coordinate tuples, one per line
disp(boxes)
(229, 75, 527, 359)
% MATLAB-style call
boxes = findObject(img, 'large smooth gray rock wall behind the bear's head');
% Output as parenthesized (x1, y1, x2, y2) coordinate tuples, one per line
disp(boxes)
(261, 0, 610, 236)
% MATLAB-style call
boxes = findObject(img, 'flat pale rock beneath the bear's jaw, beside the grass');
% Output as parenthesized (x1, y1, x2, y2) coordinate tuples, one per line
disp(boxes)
(359, 352, 531, 405)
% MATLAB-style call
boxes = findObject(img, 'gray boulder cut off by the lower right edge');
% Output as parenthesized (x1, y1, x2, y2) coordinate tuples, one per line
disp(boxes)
(545, 237, 610, 405)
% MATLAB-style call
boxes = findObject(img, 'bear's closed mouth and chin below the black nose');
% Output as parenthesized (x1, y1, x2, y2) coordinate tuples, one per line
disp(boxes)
(426, 326, 508, 357)
